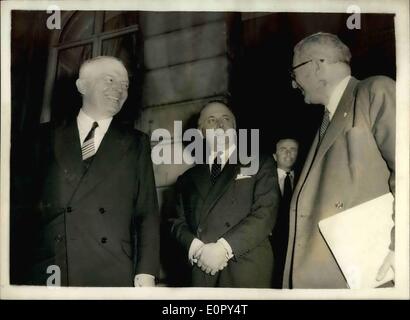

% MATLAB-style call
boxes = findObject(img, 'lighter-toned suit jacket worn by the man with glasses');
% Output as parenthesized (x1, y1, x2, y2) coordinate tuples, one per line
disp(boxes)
(284, 76, 395, 288)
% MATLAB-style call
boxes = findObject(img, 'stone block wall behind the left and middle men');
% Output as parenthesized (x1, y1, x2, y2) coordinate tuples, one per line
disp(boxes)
(137, 12, 235, 283)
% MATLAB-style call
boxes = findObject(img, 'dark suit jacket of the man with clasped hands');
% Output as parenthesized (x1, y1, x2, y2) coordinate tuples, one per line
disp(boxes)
(172, 157, 279, 288)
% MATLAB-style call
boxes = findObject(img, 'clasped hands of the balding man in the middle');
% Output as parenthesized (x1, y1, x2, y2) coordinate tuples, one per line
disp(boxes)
(194, 242, 228, 275)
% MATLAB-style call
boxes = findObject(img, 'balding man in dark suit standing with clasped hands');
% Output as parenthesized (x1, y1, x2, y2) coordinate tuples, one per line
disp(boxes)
(172, 101, 279, 288)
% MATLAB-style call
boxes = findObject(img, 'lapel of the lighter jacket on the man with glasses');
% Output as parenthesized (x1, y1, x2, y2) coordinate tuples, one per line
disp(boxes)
(315, 77, 359, 163)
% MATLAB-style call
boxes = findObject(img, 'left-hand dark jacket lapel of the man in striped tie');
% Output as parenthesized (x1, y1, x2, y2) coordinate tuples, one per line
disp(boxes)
(54, 120, 83, 201)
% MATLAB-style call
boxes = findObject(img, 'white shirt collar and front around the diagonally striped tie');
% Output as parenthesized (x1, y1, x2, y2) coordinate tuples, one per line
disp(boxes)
(77, 108, 112, 152)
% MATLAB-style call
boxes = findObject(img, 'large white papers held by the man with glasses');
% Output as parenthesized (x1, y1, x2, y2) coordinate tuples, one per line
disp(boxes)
(319, 193, 394, 289)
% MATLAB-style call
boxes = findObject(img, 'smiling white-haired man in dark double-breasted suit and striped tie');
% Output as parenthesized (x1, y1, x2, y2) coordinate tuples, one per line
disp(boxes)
(30, 56, 159, 287)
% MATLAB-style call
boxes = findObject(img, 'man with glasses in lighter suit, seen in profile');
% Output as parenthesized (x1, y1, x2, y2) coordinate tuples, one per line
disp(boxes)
(284, 32, 396, 288)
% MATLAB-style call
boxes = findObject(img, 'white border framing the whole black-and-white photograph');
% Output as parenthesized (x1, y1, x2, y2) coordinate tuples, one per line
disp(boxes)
(0, 0, 410, 300)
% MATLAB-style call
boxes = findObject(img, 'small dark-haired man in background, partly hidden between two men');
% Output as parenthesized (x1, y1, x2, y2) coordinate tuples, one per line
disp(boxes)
(271, 138, 299, 289)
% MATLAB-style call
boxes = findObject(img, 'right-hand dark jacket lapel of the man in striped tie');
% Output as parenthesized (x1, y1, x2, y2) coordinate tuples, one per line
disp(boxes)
(73, 119, 132, 201)
